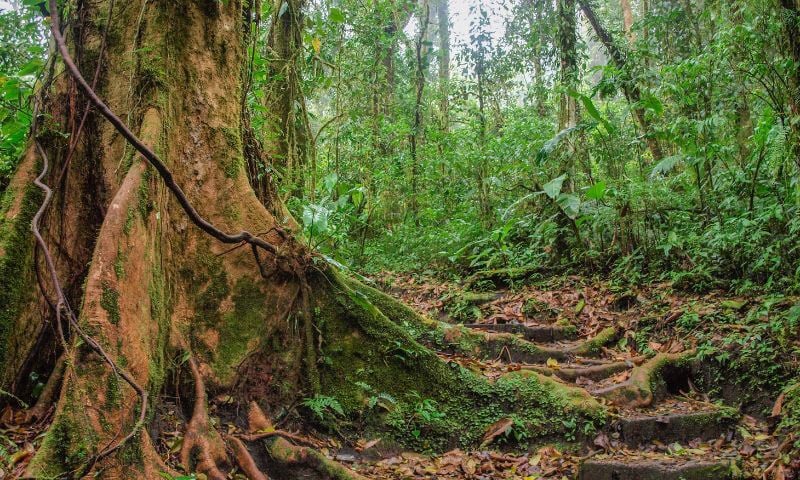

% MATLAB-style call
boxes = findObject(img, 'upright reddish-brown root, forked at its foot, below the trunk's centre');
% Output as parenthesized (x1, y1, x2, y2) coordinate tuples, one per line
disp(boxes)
(180, 356, 228, 480)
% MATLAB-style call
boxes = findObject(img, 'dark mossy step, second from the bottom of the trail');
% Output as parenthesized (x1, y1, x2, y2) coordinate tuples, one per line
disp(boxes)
(612, 409, 737, 448)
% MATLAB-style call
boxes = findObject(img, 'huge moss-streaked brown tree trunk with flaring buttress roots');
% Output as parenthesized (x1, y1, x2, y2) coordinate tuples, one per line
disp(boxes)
(0, 0, 602, 479)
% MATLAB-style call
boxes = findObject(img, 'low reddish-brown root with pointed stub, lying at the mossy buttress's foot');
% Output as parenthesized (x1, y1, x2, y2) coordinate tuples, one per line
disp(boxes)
(248, 402, 367, 480)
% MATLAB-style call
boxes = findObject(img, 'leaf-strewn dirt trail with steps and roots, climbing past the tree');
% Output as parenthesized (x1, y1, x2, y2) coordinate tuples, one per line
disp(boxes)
(350, 277, 789, 480)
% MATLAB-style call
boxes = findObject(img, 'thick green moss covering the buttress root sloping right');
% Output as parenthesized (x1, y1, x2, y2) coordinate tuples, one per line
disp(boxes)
(314, 273, 605, 451)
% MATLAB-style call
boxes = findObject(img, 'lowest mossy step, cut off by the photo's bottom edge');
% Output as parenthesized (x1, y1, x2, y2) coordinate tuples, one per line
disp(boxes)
(578, 455, 733, 480)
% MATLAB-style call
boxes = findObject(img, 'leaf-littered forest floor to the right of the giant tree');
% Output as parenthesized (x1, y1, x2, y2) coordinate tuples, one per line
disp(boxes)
(340, 273, 800, 480)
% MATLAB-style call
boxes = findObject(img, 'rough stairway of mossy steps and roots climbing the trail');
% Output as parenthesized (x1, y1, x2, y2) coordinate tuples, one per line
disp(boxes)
(464, 323, 739, 480)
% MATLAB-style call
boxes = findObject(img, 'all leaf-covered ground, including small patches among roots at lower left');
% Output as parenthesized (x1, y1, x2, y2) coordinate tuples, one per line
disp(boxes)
(0, 273, 800, 480)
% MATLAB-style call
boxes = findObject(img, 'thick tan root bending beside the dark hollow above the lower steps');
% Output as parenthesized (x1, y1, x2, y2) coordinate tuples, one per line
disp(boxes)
(594, 350, 694, 408)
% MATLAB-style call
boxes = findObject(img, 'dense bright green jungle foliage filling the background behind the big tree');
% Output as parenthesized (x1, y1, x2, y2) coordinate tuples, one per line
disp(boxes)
(0, 0, 800, 291)
